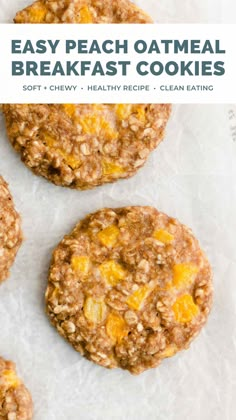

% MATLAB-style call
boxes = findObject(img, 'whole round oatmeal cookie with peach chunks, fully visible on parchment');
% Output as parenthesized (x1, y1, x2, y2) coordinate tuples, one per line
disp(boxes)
(46, 207, 212, 374)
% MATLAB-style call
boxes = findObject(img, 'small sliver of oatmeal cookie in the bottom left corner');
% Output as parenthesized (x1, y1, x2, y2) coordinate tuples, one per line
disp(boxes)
(0, 357, 33, 420)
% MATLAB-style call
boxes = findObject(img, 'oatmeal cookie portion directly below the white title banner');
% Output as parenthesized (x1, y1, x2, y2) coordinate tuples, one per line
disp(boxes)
(3, 104, 170, 189)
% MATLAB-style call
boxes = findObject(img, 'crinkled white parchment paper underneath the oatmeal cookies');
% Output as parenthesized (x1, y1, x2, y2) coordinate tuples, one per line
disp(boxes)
(0, 0, 236, 420)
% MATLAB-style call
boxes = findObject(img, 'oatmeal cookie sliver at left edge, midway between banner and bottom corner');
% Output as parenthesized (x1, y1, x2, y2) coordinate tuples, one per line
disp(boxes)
(0, 176, 22, 283)
